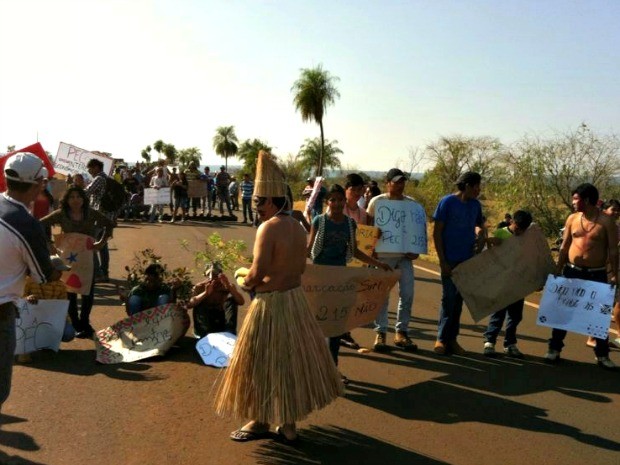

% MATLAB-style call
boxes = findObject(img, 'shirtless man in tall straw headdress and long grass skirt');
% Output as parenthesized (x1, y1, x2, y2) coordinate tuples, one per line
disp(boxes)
(216, 151, 342, 444)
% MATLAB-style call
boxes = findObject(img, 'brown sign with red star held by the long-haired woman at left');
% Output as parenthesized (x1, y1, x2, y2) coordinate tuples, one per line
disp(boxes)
(54, 233, 95, 295)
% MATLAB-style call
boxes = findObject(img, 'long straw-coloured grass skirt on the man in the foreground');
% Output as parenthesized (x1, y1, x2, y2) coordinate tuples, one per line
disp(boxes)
(215, 287, 342, 424)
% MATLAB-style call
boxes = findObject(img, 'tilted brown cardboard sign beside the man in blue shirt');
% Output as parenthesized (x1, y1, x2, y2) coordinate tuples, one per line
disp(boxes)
(452, 224, 555, 322)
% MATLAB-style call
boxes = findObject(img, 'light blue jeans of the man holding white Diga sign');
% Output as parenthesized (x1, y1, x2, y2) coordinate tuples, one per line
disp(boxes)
(375, 257, 414, 333)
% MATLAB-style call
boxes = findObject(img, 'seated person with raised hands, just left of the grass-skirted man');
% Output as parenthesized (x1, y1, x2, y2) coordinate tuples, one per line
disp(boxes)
(187, 263, 245, 338)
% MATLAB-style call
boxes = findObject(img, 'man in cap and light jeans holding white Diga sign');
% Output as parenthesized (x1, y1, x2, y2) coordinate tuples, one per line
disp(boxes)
(367, 168, 426, 352)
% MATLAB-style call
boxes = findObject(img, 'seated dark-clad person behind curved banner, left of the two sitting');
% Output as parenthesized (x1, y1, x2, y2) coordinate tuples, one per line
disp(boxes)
(125, 263, 174, 316)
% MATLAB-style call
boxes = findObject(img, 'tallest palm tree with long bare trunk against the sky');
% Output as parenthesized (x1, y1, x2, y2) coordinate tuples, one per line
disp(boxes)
(291, 65, 340, 176)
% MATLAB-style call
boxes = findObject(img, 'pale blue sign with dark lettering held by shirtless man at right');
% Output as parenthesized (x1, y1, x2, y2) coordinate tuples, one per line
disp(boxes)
(536, 274, 615, 339)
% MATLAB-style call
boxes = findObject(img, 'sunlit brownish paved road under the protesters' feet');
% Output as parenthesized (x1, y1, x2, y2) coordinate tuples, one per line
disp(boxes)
(0, 223, 620, 465)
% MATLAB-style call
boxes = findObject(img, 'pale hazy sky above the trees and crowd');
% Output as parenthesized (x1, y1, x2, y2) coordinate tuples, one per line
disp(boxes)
(0, 0, 620, 171)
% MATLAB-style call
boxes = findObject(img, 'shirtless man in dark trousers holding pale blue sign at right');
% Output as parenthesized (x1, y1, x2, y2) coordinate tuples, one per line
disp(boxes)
(545, 183, 618, 370)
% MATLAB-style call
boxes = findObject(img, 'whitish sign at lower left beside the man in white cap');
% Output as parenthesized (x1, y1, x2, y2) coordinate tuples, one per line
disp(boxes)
(15, 300, 69, 355)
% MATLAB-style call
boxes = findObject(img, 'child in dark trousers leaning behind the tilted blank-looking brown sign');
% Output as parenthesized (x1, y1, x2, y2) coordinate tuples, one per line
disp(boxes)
(483, 210, 532, 358)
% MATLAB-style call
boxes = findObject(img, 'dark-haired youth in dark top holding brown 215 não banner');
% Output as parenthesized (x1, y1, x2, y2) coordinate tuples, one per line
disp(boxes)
(308, 184, 391, 384)
